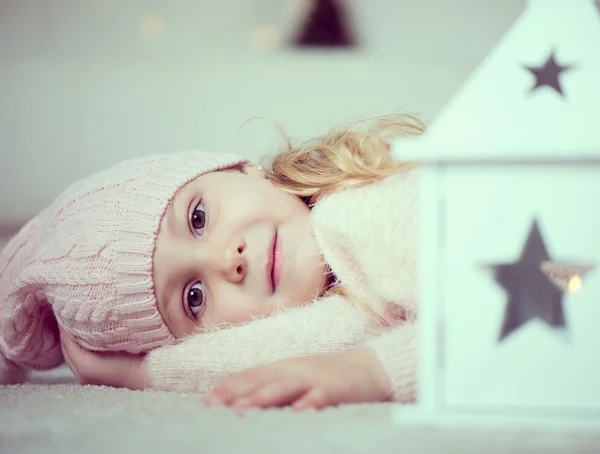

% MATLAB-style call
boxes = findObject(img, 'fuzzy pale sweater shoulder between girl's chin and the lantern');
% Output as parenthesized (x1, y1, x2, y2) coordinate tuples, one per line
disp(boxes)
(311, 172, 418, 325)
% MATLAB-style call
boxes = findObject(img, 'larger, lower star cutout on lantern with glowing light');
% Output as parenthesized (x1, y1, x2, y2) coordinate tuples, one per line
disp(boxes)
(491, 220, 593, 341)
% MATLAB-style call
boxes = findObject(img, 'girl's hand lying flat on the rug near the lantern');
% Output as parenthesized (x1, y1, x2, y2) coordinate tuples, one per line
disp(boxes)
(204, 348, 391, 411)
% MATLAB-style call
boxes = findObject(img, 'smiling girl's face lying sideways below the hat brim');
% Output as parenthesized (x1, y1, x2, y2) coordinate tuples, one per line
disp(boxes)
(153, 166, 327, 338)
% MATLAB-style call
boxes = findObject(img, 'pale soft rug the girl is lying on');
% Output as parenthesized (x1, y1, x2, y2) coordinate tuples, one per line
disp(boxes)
(0, 369, 600, 454)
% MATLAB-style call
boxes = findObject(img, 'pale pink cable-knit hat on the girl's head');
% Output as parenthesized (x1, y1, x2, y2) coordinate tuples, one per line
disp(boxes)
(0, 151, 244, 384)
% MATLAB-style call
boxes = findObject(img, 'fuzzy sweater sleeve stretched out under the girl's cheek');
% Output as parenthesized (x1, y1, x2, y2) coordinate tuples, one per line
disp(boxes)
(146, 296, 378, 393)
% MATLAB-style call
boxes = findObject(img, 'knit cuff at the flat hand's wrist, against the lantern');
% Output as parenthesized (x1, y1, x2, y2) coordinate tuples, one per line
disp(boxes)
(365, 323, 419, 403)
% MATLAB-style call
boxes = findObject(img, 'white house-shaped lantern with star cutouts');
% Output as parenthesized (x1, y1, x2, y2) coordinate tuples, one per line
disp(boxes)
(392, 0, 600, 425)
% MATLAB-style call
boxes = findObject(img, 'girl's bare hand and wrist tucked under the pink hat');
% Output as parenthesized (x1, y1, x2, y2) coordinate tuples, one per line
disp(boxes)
(60, 330, 146, 390)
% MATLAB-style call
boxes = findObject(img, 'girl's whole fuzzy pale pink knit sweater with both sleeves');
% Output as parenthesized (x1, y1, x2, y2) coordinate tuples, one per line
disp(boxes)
(147, 171, 418, 402)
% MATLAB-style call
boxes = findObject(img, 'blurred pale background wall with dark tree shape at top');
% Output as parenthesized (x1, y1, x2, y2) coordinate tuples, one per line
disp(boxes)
(0, 0, 526, 248)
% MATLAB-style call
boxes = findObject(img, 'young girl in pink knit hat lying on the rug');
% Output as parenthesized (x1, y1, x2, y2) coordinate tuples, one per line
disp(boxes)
(0, 116, 424, 409)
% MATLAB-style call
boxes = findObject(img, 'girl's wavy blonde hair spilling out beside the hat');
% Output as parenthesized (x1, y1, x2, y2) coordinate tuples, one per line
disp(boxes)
(255, 114, 425, 308)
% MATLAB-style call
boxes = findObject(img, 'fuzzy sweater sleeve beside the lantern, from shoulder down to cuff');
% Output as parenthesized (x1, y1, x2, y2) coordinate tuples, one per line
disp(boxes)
(312, 172, 419, 402)
